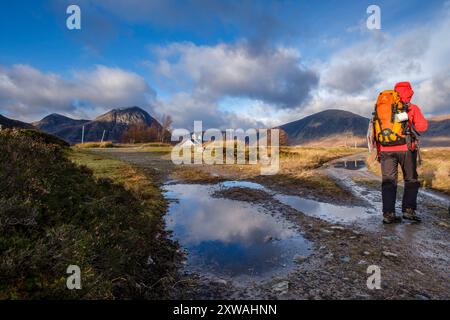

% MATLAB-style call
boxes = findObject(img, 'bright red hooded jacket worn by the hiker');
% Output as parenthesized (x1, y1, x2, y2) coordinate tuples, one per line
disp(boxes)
(380, 82, 428, 151)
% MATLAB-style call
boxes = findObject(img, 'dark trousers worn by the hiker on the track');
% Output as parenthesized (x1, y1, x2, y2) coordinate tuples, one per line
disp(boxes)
(380, 151, 420, 213)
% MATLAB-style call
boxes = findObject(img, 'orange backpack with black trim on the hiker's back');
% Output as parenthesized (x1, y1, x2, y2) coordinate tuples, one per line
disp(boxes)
(372, 90, 409, 146)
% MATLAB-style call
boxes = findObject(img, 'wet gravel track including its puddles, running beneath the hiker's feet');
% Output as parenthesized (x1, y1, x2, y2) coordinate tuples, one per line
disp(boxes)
(89, 149, 450, 299)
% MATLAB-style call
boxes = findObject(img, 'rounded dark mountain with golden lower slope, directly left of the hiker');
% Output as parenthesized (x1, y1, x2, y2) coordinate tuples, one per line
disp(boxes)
(278, 109, 369, 146)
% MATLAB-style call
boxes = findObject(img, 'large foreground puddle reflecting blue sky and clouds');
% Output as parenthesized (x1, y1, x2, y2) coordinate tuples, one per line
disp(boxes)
(165, 182, 311, 280)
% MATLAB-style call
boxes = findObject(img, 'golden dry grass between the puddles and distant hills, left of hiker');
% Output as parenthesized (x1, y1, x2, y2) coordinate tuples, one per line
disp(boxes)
(172, 147, 364, 199)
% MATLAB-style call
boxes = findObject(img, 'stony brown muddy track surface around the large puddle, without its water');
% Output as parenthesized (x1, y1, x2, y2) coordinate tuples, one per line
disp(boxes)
(89, 150, 450, 299)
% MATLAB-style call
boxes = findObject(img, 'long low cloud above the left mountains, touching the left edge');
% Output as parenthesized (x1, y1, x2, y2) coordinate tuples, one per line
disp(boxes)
(0, 65, 155, 121)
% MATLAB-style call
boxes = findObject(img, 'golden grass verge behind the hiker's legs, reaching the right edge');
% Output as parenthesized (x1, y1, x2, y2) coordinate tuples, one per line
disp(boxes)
(366, 148, 450, 194)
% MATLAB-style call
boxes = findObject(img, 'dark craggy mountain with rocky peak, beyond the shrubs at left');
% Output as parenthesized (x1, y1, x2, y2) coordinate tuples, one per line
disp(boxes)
(34, 107, 161, 143)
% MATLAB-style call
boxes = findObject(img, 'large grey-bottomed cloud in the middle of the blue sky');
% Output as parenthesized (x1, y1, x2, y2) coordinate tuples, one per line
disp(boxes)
(154, 42, 318, 108)
